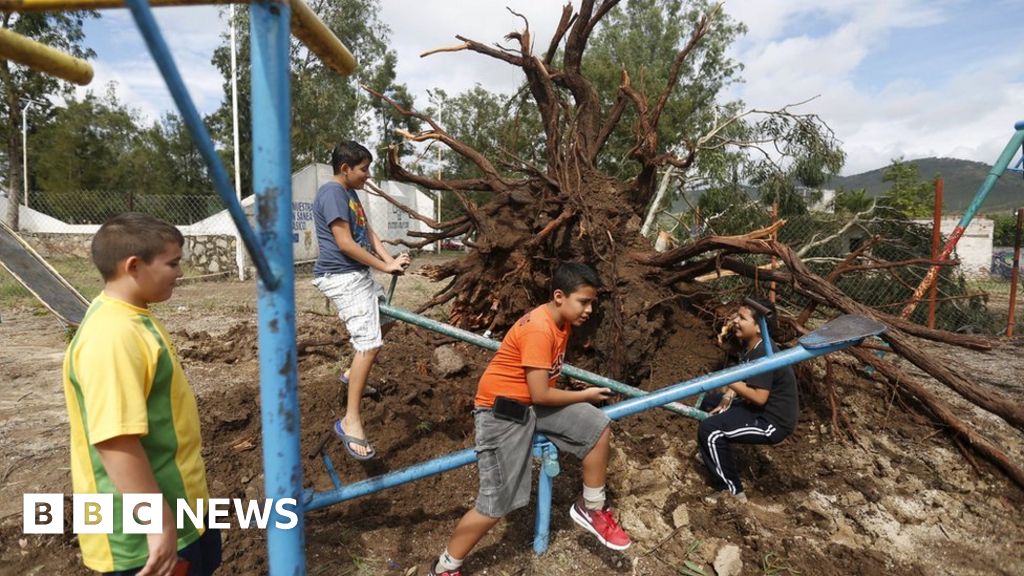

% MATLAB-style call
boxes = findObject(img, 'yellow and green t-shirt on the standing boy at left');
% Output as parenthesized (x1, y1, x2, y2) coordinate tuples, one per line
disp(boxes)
(63, 294, 209, 572)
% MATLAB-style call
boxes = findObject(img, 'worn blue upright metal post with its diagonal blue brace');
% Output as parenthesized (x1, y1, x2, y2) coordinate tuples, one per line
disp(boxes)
(127, 0, 303, 576)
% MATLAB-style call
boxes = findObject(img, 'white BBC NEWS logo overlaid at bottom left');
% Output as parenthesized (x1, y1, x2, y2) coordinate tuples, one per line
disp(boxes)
(22, 494, 299, 534)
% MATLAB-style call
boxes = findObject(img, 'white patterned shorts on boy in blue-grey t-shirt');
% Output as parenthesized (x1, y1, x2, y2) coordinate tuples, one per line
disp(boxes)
(313, 269, 394, 352)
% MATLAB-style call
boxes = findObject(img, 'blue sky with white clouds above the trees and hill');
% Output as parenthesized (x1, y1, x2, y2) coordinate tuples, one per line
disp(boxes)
(75, 0, 1024, 174)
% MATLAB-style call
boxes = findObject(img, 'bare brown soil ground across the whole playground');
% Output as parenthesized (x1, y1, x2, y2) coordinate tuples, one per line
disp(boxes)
(0, 258, 1024, 576)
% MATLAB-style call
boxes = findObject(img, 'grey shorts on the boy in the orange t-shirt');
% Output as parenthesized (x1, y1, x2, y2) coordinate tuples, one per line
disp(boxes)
(474, 402, 611, 518)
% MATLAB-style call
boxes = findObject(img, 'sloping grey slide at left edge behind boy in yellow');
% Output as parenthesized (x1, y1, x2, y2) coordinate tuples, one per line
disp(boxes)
(0, 216, 89, 327)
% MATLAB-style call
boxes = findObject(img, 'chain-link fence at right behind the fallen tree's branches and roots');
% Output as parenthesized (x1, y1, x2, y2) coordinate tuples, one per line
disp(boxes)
(657, 202, 1010, 335)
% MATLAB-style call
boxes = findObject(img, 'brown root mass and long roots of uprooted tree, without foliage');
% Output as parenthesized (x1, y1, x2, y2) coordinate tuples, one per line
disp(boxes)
(366, 0, 1024, 482)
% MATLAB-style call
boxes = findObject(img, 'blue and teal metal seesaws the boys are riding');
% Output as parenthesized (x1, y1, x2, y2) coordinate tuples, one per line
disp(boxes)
(303, 302, 886, 554)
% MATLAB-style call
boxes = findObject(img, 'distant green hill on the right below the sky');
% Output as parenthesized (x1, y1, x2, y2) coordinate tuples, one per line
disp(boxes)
(824, 158, 1024, 214)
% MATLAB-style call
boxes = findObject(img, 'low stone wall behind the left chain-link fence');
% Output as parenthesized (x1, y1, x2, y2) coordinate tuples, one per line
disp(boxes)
(20, 233, 241, 276)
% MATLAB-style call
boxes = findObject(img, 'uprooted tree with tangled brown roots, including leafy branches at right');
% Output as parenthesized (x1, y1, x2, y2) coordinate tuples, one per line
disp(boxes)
(368, 0, 1024, 485)
